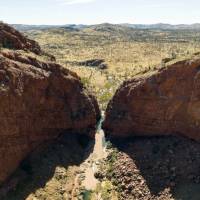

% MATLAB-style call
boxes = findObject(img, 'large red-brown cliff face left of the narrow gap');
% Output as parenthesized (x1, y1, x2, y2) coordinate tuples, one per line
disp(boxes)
(0, 25, 100, 187)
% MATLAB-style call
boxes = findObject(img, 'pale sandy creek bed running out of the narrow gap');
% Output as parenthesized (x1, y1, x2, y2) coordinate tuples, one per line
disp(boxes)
(72, 112, 107, 199)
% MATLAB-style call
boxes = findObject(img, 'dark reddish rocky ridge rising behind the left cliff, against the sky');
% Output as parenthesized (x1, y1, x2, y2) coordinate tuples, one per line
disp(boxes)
(0, 22, 42, 54)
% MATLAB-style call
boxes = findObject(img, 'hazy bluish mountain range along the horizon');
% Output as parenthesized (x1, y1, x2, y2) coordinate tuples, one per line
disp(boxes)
(12, 23, 200, 31)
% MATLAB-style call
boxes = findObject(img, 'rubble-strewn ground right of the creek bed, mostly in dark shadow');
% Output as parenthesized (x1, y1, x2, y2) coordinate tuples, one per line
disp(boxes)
(107, 136, 200, 200)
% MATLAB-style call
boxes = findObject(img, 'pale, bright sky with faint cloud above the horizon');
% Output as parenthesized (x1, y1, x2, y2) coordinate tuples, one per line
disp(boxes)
(0, 0, 200, 25)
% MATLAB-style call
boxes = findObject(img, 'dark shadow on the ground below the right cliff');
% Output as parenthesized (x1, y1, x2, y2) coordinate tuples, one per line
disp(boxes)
(113, 137, 200, 200)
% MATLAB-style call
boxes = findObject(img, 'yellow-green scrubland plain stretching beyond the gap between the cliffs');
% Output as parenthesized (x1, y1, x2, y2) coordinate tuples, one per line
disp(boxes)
(25, 24, 200, 109)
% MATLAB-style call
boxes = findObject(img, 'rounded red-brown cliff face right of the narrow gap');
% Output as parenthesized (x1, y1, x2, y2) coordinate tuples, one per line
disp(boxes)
(103, 59, 200, 141)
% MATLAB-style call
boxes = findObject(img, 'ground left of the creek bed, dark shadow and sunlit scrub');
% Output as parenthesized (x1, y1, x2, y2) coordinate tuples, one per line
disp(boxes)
(0, 134, 94, 200)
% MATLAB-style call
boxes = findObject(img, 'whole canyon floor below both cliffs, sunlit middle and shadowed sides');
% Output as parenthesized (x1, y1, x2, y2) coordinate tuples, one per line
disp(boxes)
(2, 130, 200, 200)
